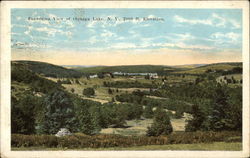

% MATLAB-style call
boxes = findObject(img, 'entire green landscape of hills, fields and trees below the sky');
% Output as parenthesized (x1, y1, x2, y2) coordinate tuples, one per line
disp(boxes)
(11, 61, 243, 150)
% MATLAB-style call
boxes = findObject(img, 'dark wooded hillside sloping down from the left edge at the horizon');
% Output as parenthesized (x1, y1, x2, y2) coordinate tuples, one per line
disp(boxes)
(12, 61, 83, 77)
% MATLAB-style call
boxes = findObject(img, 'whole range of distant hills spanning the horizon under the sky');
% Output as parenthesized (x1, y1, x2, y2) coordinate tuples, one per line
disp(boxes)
(12, 61, 242, 78)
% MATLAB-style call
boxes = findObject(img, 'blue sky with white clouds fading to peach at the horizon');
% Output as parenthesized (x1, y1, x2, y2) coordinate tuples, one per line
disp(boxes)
(11, 9, 242, 65)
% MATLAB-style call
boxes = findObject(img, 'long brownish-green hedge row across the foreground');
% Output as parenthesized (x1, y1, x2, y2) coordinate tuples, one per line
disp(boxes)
(11, 132, 241, 148)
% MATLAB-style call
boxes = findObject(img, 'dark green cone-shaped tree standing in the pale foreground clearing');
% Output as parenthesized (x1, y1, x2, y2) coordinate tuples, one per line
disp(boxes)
(147, 107, 173, 136)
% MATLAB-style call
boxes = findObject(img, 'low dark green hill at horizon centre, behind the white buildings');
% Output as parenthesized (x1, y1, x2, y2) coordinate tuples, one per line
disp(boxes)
(75, 65, 181, 74)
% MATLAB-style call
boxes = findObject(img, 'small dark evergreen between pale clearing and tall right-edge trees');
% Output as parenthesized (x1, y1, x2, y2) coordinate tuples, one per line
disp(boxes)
(185, 104, 205, 132)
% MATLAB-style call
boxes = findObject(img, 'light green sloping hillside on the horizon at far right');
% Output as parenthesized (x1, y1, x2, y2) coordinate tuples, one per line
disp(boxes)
(174, 62, 242, 74)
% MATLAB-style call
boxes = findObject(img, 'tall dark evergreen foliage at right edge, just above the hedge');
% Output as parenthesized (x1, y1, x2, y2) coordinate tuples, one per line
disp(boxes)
(211, 84, 242, 131)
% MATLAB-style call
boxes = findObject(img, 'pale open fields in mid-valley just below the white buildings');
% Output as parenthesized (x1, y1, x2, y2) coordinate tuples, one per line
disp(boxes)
(54, 75, 196, 103)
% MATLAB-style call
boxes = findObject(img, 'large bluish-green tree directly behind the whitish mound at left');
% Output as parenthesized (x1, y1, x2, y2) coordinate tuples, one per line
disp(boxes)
(40, 91, 76, 134)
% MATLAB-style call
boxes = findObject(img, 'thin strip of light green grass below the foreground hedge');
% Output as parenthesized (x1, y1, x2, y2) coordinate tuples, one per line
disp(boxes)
(11, 142, 242, 151)
